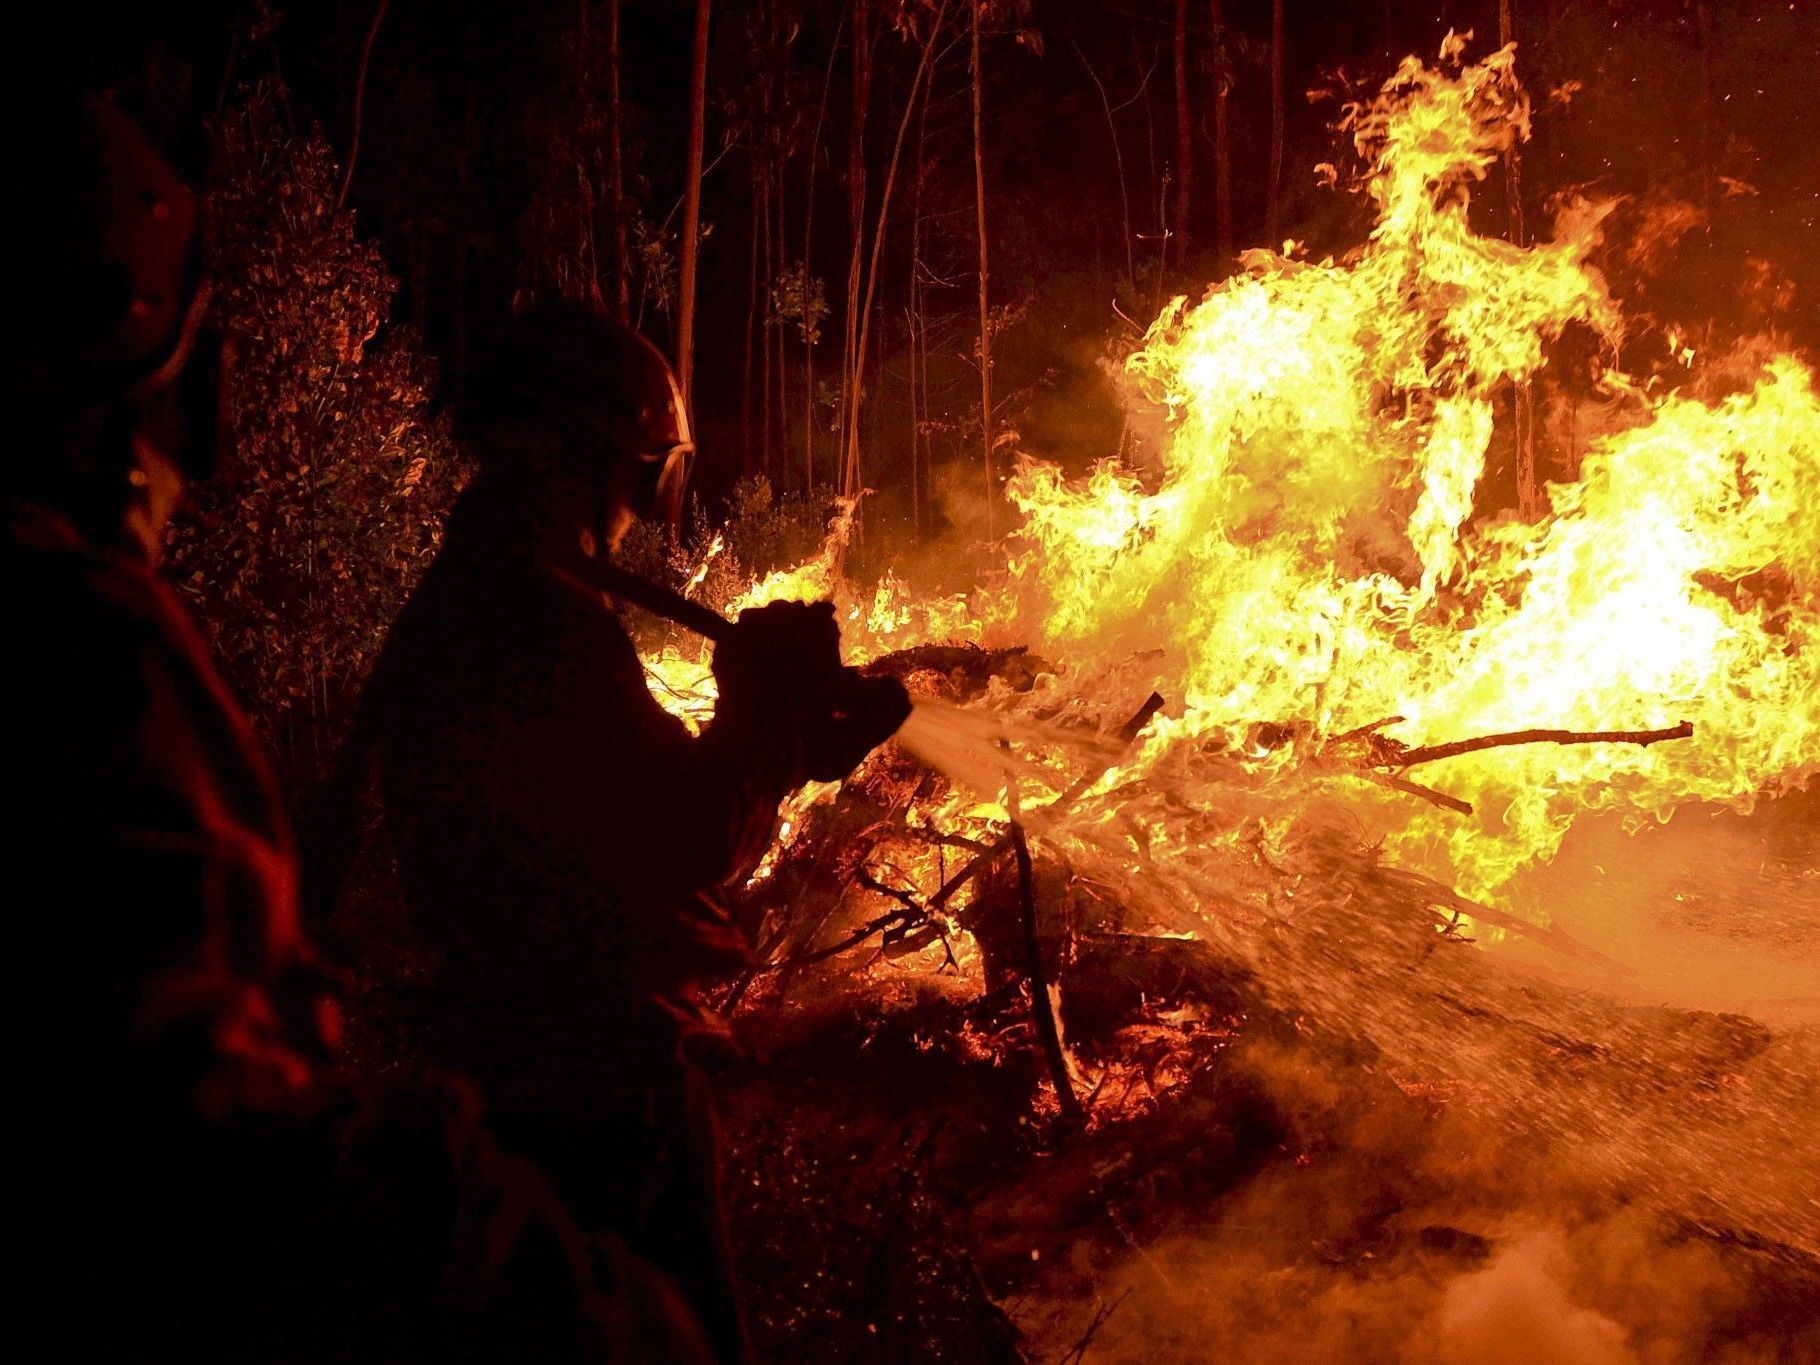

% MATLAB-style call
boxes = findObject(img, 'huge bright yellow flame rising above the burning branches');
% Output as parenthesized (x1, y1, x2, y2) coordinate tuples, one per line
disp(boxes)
(1012, 40, 1820, 892)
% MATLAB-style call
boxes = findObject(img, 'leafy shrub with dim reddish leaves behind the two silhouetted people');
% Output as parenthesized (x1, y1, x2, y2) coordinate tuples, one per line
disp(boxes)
(169, 80, 466, 784)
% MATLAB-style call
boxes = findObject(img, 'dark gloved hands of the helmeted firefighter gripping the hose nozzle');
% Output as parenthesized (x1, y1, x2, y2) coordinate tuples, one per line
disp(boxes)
(713, 602, 910, 781)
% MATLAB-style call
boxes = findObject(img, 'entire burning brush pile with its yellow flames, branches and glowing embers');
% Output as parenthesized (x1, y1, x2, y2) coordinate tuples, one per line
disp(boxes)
(633, 37, 1820, 1360)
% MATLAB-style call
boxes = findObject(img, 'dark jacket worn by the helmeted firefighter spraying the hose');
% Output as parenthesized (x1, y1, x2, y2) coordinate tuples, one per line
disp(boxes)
(362, 488, 801, 1097)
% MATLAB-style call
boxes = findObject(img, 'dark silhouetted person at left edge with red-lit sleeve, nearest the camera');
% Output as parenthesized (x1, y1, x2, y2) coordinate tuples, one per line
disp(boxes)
(4, 96, 673, 1361)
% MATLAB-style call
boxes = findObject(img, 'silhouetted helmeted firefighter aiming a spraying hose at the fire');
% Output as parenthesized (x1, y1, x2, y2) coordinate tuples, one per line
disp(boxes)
(345, 306, 908, 1360)
